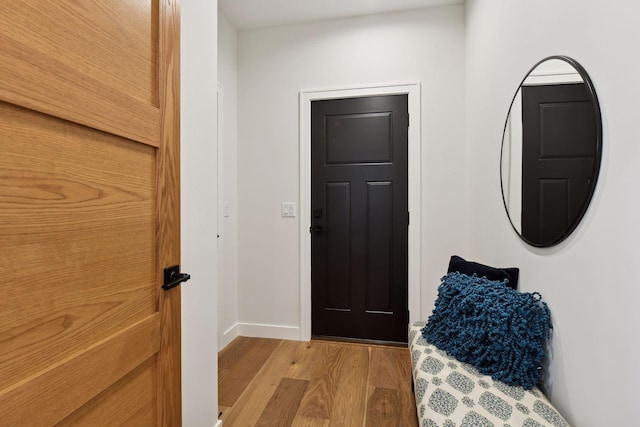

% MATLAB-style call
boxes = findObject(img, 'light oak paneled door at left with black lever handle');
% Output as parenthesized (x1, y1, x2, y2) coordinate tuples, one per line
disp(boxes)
(0, 0, 181, 426)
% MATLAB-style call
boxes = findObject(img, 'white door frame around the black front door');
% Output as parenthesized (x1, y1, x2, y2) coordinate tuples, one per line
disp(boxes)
(299, 83, 422, 341)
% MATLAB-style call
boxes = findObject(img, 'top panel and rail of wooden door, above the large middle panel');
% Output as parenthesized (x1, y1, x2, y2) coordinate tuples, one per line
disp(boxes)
(0, 1, 160, 146)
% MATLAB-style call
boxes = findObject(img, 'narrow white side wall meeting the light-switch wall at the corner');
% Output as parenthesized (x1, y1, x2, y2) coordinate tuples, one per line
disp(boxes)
(218, 11, 238, 349)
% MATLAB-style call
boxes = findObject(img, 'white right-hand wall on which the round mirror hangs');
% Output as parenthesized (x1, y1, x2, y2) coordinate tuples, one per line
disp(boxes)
(466, 0, 640, 427)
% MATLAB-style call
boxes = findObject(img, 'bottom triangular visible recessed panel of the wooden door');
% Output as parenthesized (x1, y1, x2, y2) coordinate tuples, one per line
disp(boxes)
(56, 357, 158, 427)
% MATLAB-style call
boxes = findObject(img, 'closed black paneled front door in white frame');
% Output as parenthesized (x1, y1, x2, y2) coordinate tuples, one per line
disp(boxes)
(310, 95, 409, 343)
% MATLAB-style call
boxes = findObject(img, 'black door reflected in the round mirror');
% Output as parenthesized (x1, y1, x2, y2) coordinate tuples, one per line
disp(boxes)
(522, 83, 596, 245)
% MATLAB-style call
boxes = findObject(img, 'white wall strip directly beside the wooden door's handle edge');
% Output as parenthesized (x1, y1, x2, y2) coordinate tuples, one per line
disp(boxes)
(180, 0, 218, 427)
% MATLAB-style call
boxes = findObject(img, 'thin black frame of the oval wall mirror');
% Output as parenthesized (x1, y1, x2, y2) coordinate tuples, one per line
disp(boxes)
(500, 55, 602, 248)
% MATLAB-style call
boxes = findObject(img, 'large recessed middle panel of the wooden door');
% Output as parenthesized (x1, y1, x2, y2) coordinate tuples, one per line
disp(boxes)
(0, 99, 156, 389)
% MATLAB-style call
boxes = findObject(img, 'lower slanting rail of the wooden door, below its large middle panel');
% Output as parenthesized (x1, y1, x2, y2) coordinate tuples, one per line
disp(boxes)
(0, 314, 160, 426)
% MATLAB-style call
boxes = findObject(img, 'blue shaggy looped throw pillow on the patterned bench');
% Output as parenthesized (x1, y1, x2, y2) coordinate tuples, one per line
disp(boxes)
(422, 272, 552, 390)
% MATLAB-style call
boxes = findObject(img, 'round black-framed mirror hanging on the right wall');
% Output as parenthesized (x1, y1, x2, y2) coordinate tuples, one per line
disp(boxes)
(500, 56, 602, 247)
